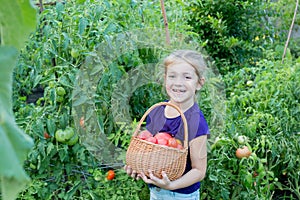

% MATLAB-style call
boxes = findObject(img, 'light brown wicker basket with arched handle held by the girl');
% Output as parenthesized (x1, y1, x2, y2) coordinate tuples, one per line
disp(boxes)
(126, 102, 188, 180)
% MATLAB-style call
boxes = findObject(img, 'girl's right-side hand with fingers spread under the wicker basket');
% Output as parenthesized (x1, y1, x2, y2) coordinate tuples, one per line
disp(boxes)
(138, 171, 172, 190)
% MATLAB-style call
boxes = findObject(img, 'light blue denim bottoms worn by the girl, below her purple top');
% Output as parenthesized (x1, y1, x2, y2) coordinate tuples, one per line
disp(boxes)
(149, 187, 200, 200)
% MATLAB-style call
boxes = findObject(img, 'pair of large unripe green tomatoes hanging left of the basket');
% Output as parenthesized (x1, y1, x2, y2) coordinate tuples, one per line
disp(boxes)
(55, 126, 79, 146)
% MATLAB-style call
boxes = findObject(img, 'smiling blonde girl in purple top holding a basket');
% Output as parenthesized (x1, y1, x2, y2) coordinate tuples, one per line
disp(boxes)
(124, 50, 209, 200)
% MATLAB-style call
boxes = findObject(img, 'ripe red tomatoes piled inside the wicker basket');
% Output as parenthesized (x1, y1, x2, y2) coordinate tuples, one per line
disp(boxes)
(137, 130, 183, 149)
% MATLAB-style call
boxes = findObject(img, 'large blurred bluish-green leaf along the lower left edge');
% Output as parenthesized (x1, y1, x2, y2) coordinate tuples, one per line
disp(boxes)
(0, 47, 33, 200)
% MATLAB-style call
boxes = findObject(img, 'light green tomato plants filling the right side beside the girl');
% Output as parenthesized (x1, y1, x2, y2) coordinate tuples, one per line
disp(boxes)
(202, 52, 300, 199)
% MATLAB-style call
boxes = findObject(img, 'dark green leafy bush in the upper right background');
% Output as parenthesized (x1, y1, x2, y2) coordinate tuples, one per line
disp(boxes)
(188, 0, 292, 74)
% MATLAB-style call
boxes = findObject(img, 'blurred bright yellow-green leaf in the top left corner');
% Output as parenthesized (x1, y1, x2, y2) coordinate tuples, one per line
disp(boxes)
(0, 0, 36, 49)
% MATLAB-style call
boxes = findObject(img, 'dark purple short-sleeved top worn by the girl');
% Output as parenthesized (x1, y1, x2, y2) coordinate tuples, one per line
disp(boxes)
(146, 103, 209, 194)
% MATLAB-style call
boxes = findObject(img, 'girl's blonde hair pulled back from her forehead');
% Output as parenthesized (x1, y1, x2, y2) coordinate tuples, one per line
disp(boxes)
(163, 50, 207, 82)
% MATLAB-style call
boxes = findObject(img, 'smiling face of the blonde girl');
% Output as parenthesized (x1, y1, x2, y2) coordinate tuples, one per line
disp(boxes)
(165, 62, 201, 107)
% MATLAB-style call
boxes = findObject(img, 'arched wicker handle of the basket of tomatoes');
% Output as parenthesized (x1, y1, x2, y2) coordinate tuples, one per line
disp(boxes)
(133, 102, 188, 148)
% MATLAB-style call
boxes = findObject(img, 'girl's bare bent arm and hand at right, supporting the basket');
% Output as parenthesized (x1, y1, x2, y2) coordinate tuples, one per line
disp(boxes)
(141, 135, 207, 190)
